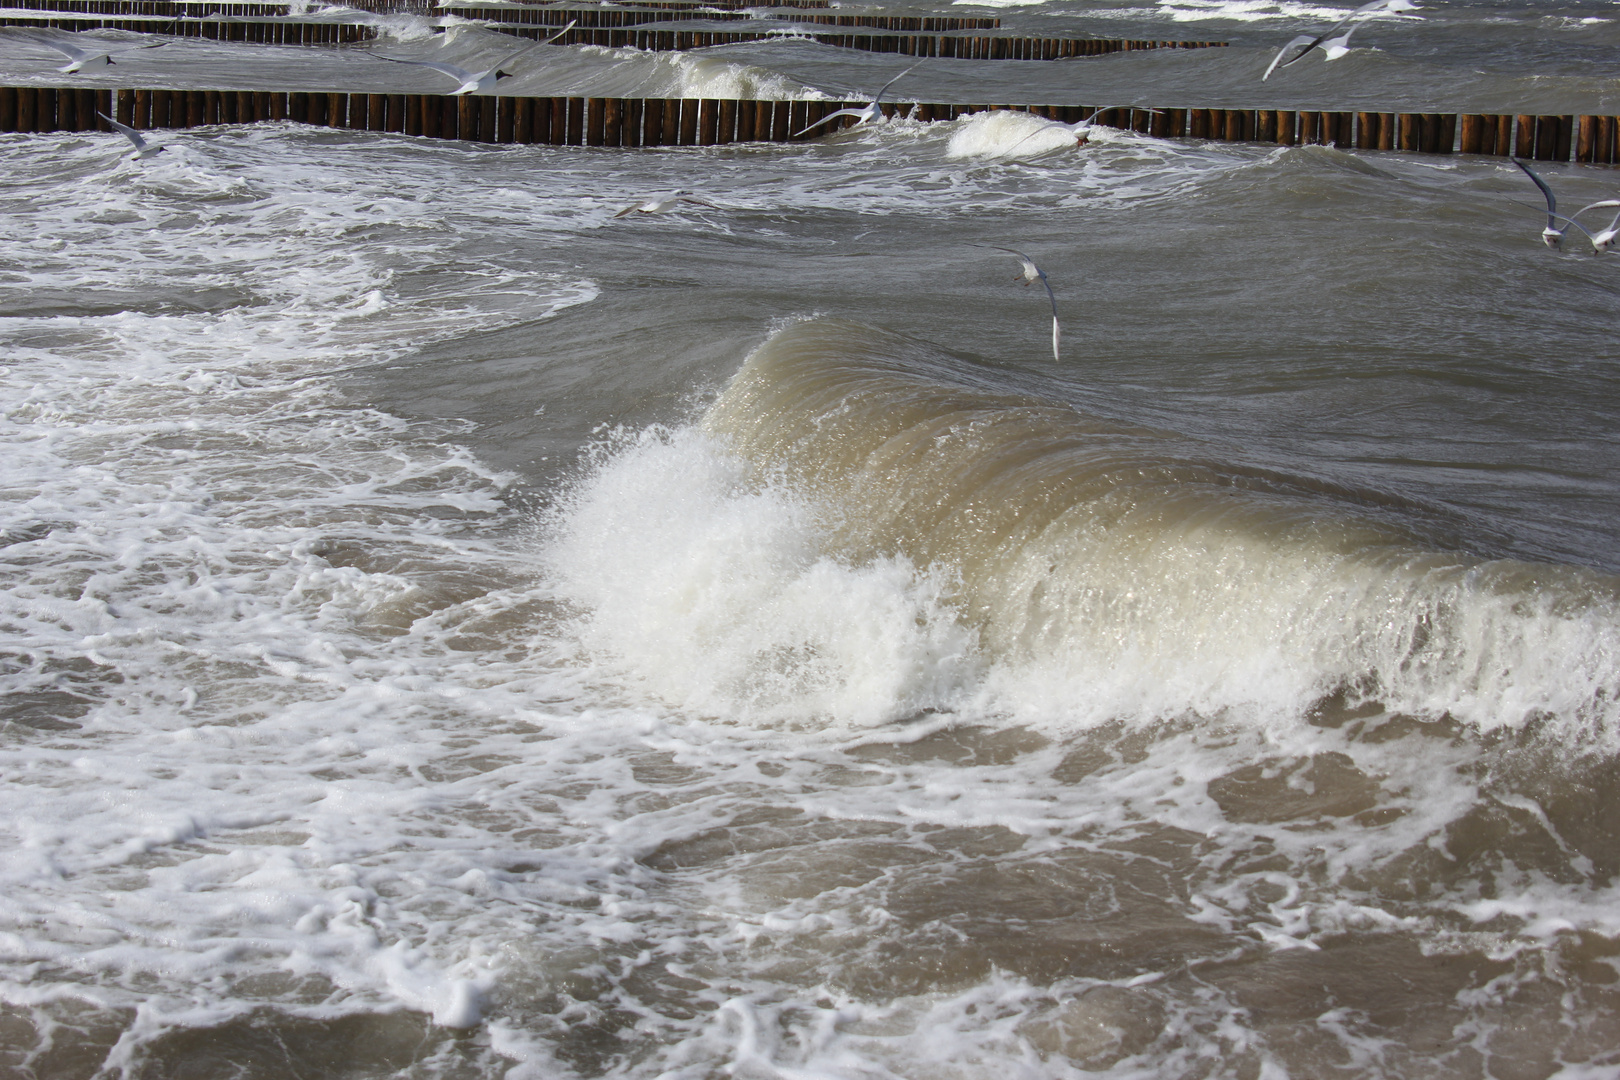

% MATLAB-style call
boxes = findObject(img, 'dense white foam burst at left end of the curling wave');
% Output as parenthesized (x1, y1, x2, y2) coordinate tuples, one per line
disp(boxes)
(549, 431, 977, 725)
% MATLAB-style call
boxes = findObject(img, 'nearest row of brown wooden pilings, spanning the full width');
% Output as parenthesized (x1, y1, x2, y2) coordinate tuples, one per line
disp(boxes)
(0, 86, 1620, 164)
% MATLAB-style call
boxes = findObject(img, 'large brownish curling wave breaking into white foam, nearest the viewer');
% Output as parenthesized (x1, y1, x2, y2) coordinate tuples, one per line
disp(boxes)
(557, 321, 1620, 743)
